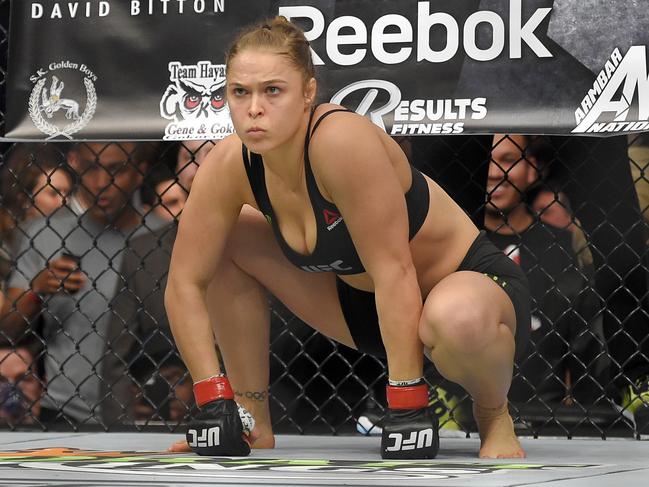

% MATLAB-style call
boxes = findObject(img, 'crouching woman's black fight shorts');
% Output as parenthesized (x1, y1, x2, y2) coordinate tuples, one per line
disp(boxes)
(336, 231, 531, 358)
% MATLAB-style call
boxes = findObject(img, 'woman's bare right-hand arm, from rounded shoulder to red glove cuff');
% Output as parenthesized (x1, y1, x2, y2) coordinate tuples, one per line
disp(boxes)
(310, 113, 423, 380)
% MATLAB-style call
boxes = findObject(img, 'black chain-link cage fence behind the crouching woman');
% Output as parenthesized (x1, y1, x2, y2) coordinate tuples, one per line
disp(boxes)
(0, 0, 649, 437)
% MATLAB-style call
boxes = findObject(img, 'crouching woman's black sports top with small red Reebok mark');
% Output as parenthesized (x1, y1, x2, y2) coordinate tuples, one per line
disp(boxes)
(243, 108, 430, 274)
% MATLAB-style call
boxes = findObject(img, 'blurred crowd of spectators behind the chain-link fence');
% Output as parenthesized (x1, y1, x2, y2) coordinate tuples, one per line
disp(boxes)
(0, 134, 649, 434)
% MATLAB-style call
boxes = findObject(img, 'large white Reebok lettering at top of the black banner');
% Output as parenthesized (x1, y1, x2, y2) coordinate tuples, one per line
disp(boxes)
(278, 0, 552, 66)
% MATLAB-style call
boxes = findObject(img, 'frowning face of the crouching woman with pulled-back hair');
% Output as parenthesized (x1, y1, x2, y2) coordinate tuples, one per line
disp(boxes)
(227, 49, 315, 154)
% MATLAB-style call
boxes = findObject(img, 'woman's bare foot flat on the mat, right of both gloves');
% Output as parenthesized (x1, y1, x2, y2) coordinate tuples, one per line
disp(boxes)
(473, 403, 525, 458)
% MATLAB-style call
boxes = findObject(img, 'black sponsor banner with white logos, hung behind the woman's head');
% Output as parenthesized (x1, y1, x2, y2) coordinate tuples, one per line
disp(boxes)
(4, 0, 649, 140)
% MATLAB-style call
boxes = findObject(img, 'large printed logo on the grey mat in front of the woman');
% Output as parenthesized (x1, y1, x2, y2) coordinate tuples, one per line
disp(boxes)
(0, 448, 600, 484)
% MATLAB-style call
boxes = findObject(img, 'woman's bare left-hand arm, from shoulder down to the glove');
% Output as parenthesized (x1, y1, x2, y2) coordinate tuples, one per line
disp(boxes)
(165, 137, 245, 382)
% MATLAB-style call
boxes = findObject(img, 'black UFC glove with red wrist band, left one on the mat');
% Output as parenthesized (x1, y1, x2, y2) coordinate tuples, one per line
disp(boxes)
(186, 376, 250, 456)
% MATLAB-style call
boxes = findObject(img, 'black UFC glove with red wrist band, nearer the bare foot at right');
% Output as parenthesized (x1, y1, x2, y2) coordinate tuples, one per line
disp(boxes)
(381, 383, 439, 460)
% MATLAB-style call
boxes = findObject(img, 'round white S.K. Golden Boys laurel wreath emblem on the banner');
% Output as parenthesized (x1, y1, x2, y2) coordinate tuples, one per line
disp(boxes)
(29, 61, 97, 139)
